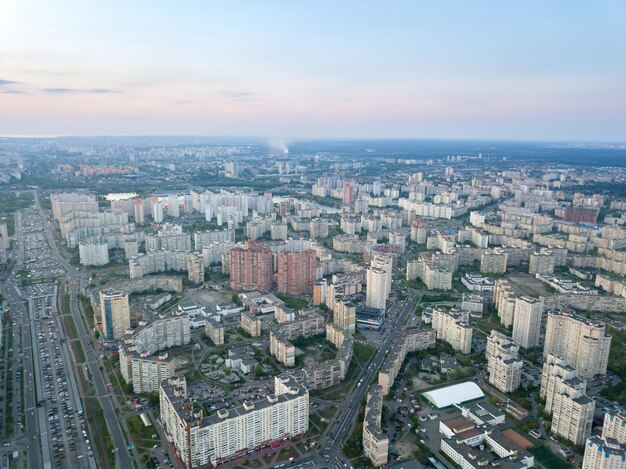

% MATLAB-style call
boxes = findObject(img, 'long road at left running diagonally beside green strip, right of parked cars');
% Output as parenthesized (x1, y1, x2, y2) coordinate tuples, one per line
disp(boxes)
(34, 191, 133, 468)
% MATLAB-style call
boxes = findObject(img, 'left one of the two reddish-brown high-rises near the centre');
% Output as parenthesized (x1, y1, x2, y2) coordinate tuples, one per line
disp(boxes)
(230, 241, 274, 291)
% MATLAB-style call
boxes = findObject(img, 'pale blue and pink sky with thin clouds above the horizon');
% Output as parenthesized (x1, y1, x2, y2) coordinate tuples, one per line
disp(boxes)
(0, 0, 626, 142)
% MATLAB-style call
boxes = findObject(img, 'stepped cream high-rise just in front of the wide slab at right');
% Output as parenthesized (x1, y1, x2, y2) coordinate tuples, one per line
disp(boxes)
(539, 355, 595, 445)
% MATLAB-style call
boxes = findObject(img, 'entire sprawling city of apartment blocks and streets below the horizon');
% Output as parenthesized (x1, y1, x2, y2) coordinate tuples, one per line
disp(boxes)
(0, 138, 626, 468)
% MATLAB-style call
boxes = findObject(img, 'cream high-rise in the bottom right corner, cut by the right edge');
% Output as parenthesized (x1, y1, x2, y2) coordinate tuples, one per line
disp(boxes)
(582, 412, 626, 469)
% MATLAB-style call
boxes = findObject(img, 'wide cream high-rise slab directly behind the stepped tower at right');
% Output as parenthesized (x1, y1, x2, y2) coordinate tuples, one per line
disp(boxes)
(543, 310, 611, 379)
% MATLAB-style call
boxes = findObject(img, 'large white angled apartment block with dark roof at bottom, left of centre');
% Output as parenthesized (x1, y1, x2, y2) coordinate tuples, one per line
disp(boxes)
(159, 375, 309, 468)
